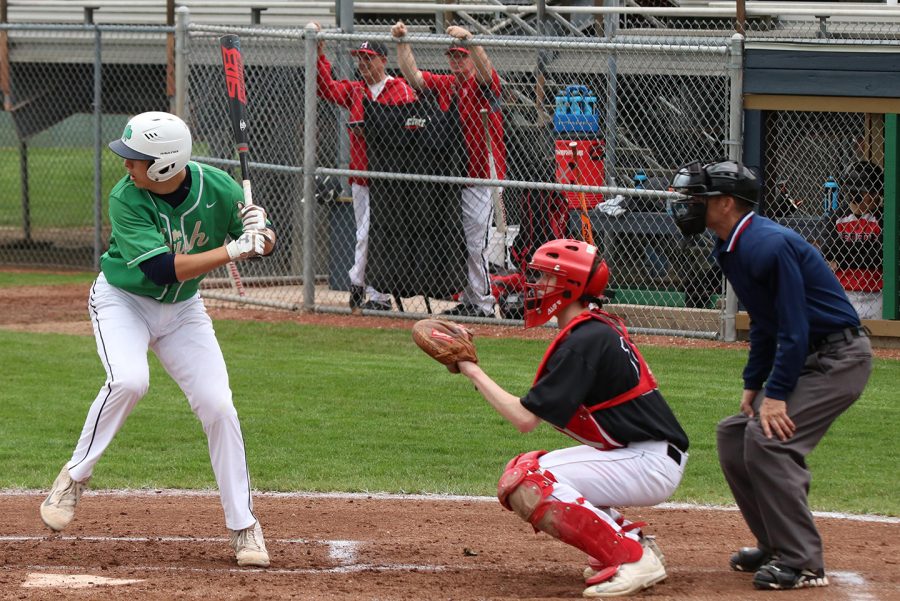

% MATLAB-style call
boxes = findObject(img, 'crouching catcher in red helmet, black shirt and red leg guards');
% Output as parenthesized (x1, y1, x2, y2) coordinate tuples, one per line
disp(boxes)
(442, 240, 688, 598)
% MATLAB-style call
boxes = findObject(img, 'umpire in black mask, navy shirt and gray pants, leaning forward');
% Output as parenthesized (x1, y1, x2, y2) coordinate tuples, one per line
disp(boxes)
(669, 161, 872, 590)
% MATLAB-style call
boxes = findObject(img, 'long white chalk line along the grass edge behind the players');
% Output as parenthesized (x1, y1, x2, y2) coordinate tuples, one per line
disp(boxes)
(0, 488, 900, 524)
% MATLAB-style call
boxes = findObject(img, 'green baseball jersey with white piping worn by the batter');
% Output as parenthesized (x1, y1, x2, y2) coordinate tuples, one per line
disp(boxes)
(100, 162, 244, 303)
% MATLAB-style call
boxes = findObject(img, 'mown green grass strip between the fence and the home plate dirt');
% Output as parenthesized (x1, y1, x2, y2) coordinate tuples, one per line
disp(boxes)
(0, 321, 900, 515)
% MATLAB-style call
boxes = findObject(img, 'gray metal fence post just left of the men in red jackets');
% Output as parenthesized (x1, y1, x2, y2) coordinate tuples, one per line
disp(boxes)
(302, 25, 318, 309)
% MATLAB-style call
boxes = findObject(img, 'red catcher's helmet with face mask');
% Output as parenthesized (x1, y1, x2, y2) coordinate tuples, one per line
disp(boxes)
(525, 240, 609, 328)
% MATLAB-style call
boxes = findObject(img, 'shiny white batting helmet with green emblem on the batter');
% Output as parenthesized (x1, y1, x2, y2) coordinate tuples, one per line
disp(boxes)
(109, 111, 191, 182)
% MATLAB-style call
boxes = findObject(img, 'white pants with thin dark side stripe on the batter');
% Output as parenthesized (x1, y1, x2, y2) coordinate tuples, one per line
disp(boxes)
(67, 273, 256, 530)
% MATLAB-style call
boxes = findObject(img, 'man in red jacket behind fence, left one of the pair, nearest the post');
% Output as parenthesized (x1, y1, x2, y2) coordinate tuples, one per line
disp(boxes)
(313, 23, 416, 311)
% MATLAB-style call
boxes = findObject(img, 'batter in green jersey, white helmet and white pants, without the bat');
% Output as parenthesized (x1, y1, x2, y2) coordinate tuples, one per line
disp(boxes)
(41, 112, 275, 567)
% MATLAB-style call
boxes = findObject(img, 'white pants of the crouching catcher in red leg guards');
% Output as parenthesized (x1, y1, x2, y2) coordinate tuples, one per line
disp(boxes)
(539, 441, 688, 539)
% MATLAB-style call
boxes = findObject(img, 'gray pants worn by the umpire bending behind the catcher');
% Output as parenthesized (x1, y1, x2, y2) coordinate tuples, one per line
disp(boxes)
(716, 337, 872, 570)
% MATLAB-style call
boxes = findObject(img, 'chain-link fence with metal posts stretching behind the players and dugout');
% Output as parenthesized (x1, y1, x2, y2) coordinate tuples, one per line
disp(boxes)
(0, 9, 898, 337)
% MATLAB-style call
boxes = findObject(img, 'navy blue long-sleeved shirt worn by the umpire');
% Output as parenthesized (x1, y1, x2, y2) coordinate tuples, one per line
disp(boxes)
(713, 212, 860, 401)
